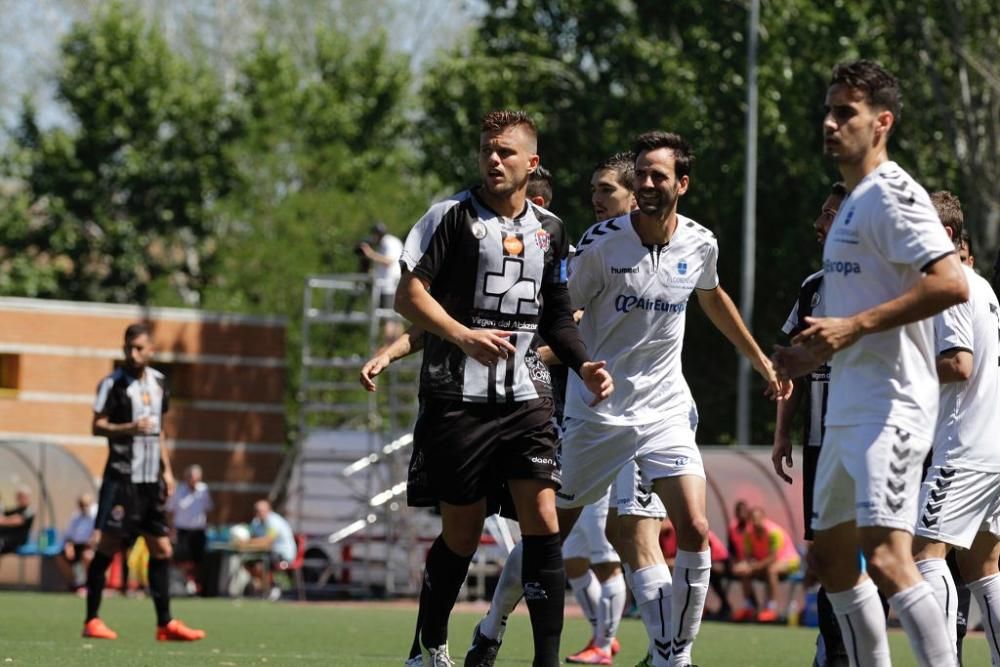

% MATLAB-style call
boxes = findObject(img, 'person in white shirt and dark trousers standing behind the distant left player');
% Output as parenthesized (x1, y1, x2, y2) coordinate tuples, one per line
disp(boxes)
(167, 464, 215, 595)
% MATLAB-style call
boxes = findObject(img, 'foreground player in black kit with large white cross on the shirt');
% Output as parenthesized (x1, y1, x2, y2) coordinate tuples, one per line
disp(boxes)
(396, 112, 612, 667)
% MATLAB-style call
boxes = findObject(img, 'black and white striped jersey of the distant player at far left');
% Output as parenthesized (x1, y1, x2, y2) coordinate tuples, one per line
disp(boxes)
(94, 367, 170, 484)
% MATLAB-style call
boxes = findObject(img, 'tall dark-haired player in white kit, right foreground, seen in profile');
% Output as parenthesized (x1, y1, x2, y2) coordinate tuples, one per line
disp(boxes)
(774, 60, 969, 667)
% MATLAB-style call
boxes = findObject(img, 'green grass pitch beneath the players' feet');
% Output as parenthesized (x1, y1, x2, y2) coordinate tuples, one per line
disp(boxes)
(0, 593, 990, 667)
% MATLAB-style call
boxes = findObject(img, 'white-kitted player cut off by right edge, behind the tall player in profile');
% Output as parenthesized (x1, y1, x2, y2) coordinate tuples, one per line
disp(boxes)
(913, 192, 1000, 665)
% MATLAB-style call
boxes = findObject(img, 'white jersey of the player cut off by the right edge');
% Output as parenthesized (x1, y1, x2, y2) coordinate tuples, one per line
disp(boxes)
(934, 266, 1000, 472)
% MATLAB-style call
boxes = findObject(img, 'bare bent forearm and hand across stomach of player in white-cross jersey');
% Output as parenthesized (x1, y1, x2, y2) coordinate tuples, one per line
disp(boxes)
(395, 271, 517, 366)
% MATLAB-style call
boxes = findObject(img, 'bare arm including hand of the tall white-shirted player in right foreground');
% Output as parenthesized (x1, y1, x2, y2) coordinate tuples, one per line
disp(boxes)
(792, 254, 969, 363)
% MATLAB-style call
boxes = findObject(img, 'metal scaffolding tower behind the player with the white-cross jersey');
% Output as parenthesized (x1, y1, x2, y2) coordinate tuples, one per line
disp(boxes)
(278, 274, 426, 595)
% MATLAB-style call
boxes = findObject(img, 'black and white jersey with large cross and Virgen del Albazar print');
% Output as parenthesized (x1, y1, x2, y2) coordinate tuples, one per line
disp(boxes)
(400, 189, 569, 403)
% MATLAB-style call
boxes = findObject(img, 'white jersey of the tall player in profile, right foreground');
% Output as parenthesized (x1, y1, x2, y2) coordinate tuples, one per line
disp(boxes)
(823, 162, 955, 441)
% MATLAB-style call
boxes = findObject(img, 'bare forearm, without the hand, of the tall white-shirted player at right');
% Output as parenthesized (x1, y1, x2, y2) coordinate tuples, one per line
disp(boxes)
(852, 255, 969, 336)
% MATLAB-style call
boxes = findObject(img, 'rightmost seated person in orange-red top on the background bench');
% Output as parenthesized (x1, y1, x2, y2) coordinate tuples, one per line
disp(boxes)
(733, 507, 799, 623)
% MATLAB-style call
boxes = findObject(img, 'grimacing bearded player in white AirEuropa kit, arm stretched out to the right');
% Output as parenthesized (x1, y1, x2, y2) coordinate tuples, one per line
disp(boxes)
(556, 132, 792, 667)
